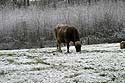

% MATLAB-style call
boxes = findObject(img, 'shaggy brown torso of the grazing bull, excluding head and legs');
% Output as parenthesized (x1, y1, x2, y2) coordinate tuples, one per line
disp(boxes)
(55, 25, 79, 43)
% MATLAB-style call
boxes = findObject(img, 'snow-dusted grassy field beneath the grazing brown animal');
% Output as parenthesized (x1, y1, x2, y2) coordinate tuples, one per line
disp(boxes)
(0, 43, 125, 83)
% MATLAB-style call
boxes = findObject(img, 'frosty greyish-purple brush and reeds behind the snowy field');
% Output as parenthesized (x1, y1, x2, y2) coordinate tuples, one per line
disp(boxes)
(0, 0, 125, 49)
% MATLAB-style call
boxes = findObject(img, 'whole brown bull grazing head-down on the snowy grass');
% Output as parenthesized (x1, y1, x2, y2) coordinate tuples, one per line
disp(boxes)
(54, 24, 81, 52)
